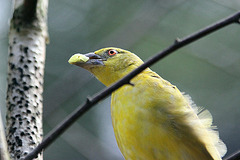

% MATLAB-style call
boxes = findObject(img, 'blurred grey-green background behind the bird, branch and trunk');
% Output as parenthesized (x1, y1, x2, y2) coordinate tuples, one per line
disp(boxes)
(0, 0, 240, 160)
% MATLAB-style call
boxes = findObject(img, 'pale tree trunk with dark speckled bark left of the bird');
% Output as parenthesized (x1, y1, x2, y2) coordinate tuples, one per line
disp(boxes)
(6, 0, 48, 160)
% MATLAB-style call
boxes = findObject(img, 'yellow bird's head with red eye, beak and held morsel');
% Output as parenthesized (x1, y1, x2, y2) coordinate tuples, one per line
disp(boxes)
(68, 47, 143, 86)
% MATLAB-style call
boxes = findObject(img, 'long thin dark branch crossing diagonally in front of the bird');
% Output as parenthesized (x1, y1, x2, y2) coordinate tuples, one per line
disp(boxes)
(24, 12, 240, 160)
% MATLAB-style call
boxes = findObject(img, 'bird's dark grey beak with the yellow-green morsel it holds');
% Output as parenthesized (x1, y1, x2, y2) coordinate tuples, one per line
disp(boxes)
(68, 52, 104, 67)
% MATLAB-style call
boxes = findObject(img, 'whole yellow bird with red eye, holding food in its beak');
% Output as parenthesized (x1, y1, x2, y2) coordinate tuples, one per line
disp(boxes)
(69, 47, 227, 160)
